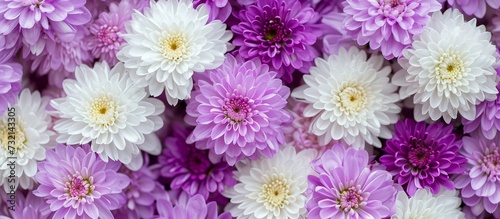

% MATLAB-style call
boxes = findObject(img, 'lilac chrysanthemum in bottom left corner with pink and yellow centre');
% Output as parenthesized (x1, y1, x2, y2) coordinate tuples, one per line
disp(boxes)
(33, 144, 130, 219)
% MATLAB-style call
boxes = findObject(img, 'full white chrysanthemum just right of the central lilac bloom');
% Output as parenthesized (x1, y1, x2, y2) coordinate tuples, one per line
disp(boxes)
(292, 47, 401, 148)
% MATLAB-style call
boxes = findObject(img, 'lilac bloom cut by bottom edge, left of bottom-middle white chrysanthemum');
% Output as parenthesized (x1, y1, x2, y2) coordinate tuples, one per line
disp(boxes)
(154, 194, 233, 219)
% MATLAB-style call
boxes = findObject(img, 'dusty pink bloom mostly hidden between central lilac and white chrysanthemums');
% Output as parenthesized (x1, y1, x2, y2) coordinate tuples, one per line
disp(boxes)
(283, 99, 336, 153)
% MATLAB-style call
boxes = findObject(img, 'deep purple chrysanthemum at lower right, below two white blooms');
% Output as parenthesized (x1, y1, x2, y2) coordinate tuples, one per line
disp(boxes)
(380, 119, 467, 196)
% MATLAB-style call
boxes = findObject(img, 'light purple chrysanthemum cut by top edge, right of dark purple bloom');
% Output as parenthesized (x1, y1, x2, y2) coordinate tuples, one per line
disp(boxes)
(344, 0, 442, 59)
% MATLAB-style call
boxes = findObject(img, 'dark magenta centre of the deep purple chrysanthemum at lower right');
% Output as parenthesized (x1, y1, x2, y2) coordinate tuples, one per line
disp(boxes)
(408, 137, 435, 169)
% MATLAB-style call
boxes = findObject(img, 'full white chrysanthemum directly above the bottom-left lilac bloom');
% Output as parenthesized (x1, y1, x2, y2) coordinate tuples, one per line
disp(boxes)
(51, 62, 165, 170)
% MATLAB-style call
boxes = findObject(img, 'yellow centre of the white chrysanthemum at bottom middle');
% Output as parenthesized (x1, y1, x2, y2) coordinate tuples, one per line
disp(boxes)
(259, 176, 290, 211)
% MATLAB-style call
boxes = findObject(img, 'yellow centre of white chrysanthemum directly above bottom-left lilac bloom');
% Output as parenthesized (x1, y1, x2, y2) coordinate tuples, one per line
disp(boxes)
(89, 95, 118, 128)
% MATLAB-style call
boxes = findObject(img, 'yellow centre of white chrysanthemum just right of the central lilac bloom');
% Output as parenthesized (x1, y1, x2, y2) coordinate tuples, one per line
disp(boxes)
(335, 84, 367, 115)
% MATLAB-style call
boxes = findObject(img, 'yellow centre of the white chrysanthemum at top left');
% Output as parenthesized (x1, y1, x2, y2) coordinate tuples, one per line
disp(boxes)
(160, 33, 187, 64)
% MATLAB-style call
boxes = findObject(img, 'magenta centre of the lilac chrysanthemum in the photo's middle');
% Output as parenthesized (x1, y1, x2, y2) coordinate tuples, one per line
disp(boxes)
(222, 94, 252, 124)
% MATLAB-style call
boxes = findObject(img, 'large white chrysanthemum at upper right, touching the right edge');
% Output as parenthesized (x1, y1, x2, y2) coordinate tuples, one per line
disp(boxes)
(393, 9, 498, 123)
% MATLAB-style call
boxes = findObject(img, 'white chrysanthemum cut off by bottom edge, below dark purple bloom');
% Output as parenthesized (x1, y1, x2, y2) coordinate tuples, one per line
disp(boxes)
(392, 188, 465, 219)
